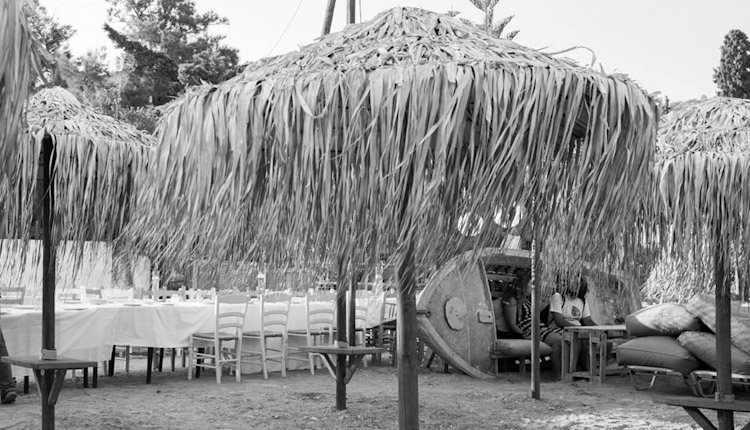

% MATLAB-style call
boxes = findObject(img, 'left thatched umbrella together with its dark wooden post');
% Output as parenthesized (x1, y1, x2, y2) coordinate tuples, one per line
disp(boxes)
(4, 88, 153, 428)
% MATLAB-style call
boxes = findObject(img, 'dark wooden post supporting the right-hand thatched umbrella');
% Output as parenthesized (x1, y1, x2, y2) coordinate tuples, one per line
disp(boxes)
(714, 237, 734, 430)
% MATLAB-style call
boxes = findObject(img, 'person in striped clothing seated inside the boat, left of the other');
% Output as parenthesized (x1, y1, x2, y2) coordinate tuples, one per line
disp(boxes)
(503, 275, 562, 377)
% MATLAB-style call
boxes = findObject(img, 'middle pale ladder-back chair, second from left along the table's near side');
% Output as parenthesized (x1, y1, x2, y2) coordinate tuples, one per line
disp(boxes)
(243, 293, 292, 379)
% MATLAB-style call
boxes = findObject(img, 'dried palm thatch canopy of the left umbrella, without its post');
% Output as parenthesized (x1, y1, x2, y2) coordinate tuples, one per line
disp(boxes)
(3, 88, 154, 243)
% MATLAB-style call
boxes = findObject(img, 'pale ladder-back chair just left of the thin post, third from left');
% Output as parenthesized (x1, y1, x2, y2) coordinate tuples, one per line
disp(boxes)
(287, 294, 336, 378)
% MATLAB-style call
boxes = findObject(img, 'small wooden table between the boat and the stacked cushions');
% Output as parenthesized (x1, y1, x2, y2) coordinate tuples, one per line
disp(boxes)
(561, 325, 627, 383)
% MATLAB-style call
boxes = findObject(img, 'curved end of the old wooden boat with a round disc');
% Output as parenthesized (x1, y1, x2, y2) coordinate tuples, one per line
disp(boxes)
(417, 248, 531, 378)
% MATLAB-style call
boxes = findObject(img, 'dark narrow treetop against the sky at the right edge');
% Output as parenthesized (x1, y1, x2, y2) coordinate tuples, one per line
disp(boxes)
(714, 30, 750, 99)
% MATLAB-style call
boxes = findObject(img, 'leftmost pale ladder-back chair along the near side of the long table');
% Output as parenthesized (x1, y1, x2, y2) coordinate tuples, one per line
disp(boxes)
(188, 294, 248, 384)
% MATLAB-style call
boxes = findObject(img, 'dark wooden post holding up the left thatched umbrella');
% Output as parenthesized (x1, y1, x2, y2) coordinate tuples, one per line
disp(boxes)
(37, 135, 55, 430)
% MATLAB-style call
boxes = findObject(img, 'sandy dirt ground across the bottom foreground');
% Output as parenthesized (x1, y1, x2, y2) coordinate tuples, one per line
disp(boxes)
(0, 357, 750, 430)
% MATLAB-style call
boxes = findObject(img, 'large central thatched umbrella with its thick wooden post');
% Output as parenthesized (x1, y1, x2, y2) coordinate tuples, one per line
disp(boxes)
(134, 8, 656, 428)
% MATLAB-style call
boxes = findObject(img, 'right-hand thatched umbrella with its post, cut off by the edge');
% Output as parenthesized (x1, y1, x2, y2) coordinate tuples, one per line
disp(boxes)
(656, 97, 750, 428)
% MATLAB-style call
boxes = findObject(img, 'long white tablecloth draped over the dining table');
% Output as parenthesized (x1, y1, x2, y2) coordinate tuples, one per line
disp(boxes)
(0, 301, 378, 376)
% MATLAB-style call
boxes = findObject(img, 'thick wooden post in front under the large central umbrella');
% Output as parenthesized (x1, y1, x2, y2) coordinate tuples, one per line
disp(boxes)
(396, 239, 419, 430)
